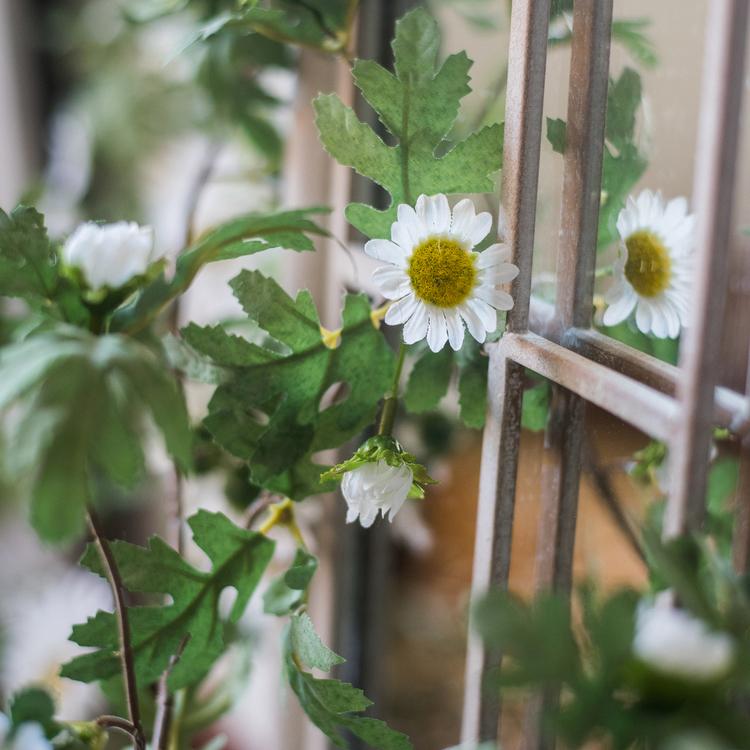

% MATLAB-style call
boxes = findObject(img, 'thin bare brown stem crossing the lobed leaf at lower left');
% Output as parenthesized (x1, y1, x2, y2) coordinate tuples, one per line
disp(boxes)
(88, 508, 146, 750)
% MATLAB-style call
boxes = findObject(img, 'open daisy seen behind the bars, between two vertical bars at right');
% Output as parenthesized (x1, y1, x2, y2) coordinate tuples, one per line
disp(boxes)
(602, 190, 695, 339)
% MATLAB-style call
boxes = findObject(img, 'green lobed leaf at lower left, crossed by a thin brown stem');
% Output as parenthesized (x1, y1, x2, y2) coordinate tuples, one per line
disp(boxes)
(61, 510, 274, 690)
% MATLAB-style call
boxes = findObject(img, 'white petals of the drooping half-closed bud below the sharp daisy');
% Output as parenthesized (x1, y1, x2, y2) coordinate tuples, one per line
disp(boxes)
(341, 460, 414, 528)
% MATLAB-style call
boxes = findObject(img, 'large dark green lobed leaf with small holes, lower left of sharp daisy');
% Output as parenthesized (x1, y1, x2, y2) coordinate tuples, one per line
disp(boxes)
(176, 271, 394, 500)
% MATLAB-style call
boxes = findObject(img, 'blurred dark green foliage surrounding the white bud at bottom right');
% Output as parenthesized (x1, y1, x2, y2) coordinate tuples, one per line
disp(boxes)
(475, 537, 750, 750)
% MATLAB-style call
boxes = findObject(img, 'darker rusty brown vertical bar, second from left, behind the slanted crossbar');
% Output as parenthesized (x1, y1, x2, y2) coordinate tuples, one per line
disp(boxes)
(524, 0, 612, 750)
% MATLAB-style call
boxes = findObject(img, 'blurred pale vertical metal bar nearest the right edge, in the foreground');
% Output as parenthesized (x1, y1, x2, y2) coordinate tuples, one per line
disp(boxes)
(664, 0, 749, 537)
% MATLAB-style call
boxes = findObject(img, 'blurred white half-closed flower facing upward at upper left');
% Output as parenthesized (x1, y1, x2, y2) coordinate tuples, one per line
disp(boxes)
(62, 221, 162, 291)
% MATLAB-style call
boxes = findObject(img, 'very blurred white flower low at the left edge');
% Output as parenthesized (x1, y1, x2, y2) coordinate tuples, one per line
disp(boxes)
(0, 569, 112, 721)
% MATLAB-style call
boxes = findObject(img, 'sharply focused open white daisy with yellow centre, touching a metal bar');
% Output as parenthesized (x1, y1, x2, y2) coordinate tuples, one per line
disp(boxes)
(365, 194, 518, 352)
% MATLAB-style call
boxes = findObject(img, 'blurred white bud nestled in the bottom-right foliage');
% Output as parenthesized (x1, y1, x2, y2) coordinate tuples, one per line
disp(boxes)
(633, 603, 734, 682)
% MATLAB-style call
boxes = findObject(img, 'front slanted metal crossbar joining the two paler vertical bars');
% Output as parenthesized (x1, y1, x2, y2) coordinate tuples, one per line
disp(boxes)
(499, 333, 678, 441)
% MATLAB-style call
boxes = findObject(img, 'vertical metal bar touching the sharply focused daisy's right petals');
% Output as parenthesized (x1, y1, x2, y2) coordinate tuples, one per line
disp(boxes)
(461, 0, 550, 743)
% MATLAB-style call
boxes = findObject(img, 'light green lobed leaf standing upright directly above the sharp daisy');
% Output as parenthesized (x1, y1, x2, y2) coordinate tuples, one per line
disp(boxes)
(314, 9, 502, 237)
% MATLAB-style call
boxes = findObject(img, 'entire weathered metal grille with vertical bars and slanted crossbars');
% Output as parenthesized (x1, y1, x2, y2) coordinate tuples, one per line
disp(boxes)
(462, 0, 750, 748)
